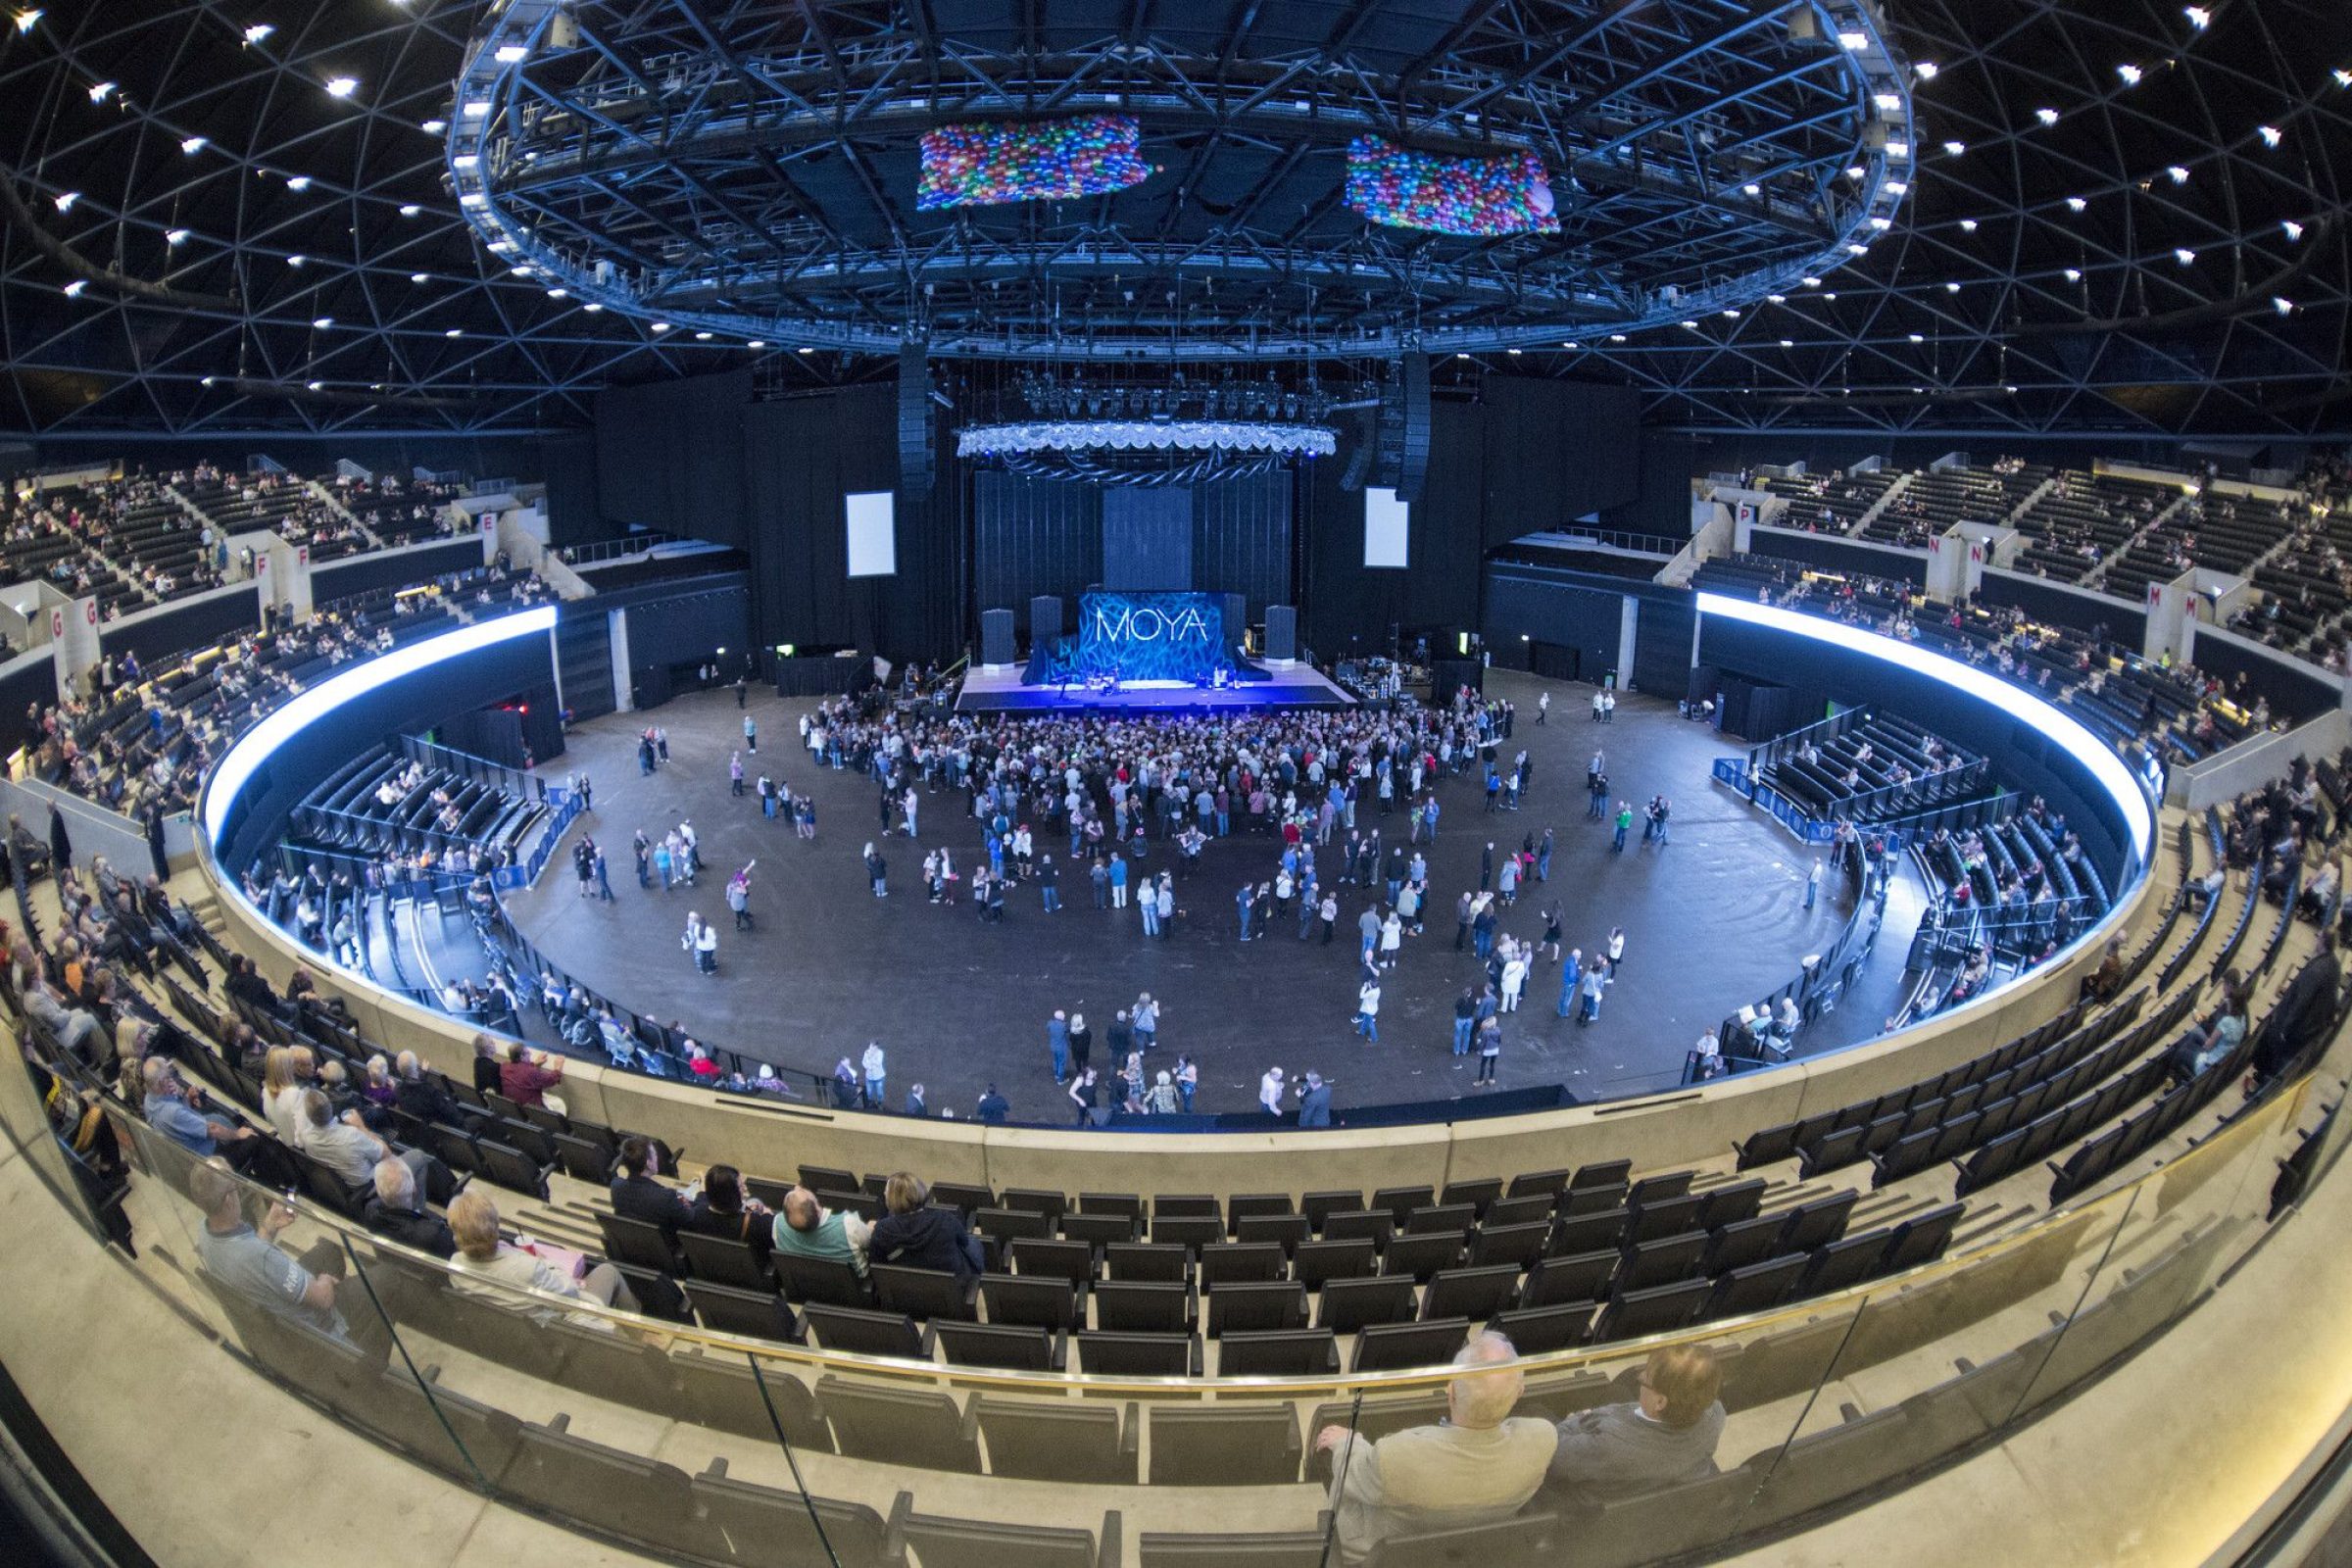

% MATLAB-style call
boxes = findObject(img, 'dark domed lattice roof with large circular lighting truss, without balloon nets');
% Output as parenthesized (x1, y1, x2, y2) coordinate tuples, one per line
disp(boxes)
(0, 0, 2352, 440)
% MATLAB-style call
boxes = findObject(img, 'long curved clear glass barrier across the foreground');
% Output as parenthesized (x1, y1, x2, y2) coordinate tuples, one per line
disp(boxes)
(0, 1020, 2312, 1568)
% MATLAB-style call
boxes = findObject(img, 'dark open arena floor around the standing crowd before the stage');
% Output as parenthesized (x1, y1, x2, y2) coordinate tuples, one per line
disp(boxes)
(496, 672, 1917, 1121)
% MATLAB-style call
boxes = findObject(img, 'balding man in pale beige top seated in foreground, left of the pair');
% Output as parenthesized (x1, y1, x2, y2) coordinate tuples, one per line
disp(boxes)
(1315, 1333, 1559, 1563)
